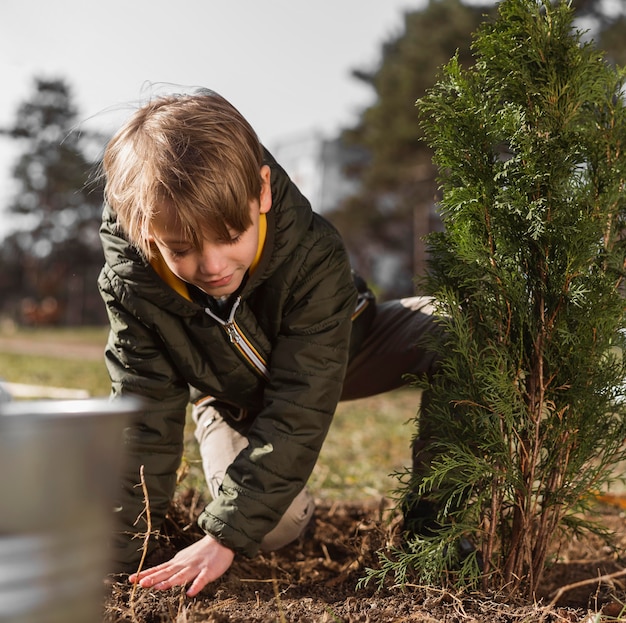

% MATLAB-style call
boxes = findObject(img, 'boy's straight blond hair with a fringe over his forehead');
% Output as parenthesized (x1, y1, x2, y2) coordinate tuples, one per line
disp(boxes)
(102, 90, 263, 258)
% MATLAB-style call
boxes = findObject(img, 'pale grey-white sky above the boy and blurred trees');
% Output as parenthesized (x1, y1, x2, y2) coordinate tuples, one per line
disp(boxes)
(0, 0, 424, 234)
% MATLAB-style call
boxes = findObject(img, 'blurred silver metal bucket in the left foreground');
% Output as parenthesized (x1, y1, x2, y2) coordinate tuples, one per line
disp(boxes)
(0, 399, 139, 623)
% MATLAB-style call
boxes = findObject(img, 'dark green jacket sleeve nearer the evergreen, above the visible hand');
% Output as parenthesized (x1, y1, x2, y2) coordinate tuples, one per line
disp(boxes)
(199, 223, 356, 556)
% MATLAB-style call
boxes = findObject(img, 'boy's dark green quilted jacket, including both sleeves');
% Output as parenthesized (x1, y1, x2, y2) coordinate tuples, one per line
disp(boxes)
(99, 155, 365, 567)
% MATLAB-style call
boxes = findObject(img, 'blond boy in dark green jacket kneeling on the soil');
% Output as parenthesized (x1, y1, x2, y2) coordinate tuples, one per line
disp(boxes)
(99, 90, 434, 596)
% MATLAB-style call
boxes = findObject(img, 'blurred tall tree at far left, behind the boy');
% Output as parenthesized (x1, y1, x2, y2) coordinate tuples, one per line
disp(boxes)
(0, 78, 106, 325)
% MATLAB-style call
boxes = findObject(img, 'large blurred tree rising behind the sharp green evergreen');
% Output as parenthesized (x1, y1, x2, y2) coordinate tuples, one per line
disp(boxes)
(329, 0, 626, 298)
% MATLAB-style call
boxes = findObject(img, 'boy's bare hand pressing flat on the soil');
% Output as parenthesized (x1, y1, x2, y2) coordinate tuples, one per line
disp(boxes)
(128, 534, 235, 597)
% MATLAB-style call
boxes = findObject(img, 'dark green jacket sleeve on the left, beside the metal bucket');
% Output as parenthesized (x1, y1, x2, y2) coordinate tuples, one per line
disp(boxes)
(99, 266, 189, 572)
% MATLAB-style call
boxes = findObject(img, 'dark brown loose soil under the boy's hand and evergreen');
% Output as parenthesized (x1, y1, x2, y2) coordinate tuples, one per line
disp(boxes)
(103, 491, 626, 623)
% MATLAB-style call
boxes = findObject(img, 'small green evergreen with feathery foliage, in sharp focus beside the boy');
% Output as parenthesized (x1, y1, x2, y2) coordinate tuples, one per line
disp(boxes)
(370, 0, 626, 595)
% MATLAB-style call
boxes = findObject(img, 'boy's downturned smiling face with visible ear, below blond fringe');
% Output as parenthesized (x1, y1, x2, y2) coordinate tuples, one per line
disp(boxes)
(151, 166, 272, 297)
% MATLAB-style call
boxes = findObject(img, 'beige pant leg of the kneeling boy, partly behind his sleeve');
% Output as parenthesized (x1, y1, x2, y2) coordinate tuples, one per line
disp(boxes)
(192, 403, 315, 551)
